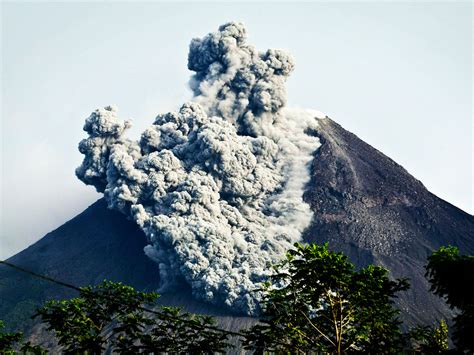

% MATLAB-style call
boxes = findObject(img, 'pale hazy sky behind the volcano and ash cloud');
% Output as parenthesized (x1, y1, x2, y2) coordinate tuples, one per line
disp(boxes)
(0, 1, 474, 258)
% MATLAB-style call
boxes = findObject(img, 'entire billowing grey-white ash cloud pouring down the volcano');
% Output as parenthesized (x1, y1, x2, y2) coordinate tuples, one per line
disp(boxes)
(76, 23, 320, 314)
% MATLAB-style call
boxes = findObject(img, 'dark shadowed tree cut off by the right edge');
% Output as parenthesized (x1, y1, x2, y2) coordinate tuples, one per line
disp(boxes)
(426, 246, 474, 353)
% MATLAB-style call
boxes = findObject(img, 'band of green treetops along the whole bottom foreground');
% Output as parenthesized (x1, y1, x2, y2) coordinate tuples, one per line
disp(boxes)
(0, 244, 474, 354)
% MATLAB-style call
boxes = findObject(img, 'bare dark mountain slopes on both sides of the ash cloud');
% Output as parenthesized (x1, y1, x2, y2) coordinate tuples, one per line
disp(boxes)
(0, 118, 474, 342)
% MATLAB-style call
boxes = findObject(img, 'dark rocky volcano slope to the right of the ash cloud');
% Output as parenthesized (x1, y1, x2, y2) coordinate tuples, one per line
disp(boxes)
(304, 118, 474, 324)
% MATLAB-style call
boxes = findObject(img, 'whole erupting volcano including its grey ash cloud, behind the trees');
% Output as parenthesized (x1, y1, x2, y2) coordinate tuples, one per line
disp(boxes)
(0, 22, 474, 350)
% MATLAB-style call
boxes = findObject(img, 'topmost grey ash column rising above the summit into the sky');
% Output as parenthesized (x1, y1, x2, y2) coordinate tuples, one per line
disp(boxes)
(188, 22, 294, 135)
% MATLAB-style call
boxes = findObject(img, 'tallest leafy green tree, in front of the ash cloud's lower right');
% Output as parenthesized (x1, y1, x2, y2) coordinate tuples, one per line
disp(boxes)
(244, 243, 408, 354)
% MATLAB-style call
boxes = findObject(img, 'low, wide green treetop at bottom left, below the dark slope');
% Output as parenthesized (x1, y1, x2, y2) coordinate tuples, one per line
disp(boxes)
(33, 281, 233, 354)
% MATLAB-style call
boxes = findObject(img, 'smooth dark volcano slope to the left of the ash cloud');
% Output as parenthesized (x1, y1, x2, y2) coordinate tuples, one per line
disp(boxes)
(0, 200, 159, 334)
